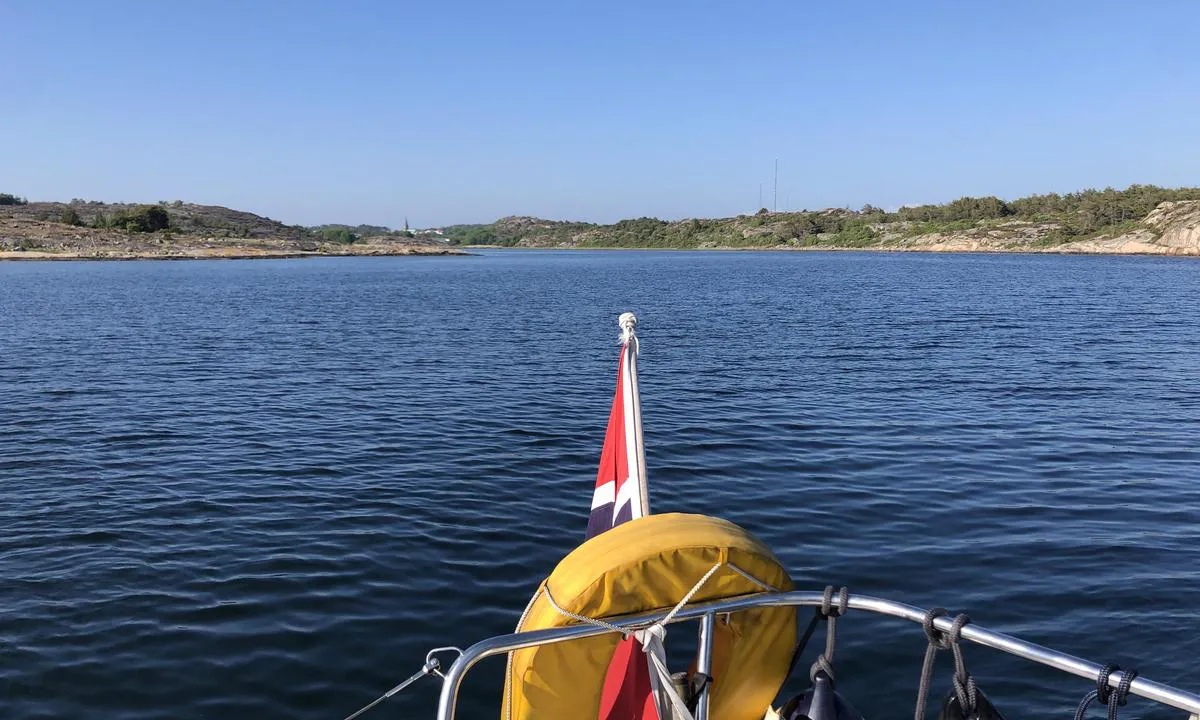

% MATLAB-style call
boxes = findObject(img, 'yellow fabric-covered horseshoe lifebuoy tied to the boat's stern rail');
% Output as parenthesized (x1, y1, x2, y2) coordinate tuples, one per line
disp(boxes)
(500, 514, 796, 720)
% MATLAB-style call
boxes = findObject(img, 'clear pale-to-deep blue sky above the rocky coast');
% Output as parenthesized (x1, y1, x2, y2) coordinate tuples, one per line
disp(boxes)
(0, 0, 1200, 227)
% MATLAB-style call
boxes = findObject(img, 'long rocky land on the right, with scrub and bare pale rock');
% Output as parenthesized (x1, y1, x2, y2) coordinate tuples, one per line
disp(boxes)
(443, 185, 1200, 256)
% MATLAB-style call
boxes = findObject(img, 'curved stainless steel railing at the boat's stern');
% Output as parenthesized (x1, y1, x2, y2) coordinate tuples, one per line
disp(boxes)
(438, 590, 1200, 720)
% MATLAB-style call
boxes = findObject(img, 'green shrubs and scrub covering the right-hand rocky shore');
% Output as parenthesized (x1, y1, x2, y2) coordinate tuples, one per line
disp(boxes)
(443, 185, 1200, 248)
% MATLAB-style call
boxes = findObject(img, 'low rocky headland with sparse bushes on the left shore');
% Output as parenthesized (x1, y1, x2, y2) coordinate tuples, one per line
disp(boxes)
(0, 193, 463, 260)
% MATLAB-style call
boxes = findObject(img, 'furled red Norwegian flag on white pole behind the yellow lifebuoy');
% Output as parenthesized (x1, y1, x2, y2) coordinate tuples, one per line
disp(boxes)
(587, 312, 659, 720)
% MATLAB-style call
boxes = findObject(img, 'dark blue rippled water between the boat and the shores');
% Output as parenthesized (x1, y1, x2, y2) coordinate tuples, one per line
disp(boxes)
(0, 252, 1200, 720)
